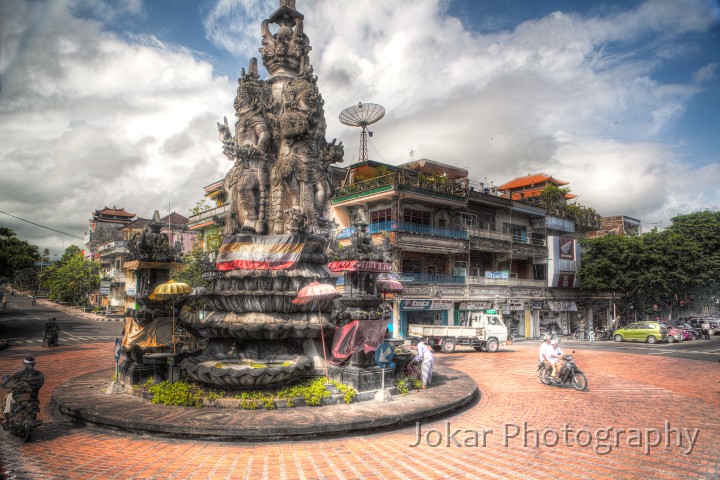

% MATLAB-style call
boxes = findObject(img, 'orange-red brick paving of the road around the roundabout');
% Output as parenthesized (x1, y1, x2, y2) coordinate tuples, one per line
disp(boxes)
(0, 342, 720, 479)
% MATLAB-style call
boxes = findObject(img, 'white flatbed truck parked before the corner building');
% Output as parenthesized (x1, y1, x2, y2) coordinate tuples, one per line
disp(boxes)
(408, 312, 507, 353)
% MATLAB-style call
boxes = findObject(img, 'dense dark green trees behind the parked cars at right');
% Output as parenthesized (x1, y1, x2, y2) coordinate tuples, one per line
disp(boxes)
(579, 212, 720, 314)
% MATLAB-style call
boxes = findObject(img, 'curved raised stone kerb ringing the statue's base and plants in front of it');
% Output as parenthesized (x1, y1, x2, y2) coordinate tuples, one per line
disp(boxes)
(51, 368, 480, 442)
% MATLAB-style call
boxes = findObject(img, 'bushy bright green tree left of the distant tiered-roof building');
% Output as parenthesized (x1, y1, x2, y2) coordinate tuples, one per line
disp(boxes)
(41, 245, 102, 303)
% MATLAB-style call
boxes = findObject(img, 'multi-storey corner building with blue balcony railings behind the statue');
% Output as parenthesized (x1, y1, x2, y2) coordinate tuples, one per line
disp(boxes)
(188, 159, 632, 337)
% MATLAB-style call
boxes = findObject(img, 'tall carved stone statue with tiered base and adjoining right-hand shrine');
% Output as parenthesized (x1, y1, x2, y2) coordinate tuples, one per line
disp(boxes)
(166, 0, 392, 391)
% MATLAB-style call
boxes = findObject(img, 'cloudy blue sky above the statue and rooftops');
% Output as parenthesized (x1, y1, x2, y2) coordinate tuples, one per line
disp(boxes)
(0, 0, 720, 253)
